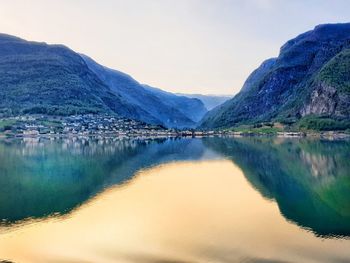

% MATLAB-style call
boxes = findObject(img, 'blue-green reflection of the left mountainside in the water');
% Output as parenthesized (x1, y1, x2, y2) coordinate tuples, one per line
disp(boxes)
(0, 138, 216, 224)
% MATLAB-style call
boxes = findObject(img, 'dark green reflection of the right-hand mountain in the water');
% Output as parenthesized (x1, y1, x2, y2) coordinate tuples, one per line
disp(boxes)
(204, 138, 350, 239)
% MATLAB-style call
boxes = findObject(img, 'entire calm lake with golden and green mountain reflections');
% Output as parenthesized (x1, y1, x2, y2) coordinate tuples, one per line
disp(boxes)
(0, 137, 350, 263)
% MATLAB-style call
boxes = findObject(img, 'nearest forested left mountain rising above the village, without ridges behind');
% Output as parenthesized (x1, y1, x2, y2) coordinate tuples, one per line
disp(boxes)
(0, 34, 156, 121)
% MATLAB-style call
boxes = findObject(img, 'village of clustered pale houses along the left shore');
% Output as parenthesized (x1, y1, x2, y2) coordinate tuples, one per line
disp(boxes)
(0, 114, 221, 137)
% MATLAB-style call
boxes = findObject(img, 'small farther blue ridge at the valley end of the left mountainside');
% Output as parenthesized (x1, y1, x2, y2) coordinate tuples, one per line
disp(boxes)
(143, 85, 208, 122)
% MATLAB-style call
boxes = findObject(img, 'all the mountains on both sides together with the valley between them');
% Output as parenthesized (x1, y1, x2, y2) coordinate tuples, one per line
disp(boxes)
(0, 23, 350, 135)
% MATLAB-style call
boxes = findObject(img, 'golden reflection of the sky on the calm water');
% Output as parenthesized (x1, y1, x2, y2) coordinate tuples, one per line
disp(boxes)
(0, 161, 350, 263)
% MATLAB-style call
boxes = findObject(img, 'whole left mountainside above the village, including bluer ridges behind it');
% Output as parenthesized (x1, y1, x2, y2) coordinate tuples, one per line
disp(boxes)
(0, 34, 206, 128)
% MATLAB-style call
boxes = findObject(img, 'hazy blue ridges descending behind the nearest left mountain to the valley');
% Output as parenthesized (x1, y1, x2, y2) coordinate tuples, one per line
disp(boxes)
(81, 55, 206, 128)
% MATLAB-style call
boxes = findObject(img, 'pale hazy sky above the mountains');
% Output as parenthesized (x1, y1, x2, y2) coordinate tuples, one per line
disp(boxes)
(0, 0, 350, 95)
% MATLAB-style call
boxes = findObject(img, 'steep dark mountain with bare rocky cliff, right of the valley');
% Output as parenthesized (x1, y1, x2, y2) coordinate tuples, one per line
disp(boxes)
(200, 23, 350, 128)
